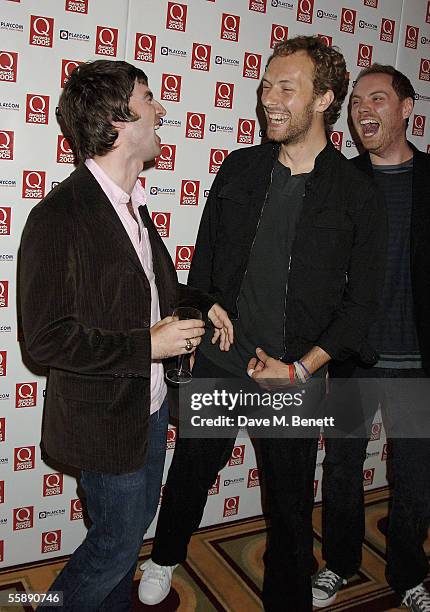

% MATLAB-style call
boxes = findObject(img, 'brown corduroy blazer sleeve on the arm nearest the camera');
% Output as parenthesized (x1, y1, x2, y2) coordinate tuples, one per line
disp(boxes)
(19, 204, 151, 378)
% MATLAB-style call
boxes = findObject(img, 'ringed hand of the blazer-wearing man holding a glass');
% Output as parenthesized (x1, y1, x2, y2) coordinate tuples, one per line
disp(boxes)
(149, 317, 205, 359)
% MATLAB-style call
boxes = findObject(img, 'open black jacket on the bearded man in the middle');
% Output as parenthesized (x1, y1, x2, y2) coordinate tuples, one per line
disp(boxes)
(188, 143, 386, 363)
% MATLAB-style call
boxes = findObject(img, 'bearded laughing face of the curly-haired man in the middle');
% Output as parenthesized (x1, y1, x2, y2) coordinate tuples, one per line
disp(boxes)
(261, 51, 317, 144)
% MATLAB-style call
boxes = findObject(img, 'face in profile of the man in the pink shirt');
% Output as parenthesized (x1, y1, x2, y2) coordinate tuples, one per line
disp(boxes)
(123, 81, 166, 162)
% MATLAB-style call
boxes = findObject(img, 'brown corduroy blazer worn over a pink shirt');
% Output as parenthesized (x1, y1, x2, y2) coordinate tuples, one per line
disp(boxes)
(20, 164, 208, 473)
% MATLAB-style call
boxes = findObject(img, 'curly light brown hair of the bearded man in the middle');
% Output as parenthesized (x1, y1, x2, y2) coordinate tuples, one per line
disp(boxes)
(269, 36, 349, 129)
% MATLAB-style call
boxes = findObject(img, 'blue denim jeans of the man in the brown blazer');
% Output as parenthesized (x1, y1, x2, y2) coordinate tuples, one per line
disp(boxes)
(40, 401, 168, 612)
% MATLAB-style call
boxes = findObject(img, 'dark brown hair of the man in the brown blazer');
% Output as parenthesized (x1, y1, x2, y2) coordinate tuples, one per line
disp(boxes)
(58, 60, 148, 162)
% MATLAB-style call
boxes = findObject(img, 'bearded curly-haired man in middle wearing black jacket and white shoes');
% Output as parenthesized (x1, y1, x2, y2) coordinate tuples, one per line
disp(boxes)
(139, 37, 384, 612)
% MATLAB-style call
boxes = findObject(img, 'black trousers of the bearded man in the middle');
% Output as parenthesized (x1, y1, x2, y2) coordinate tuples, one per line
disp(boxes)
(152, 354, 318, 612)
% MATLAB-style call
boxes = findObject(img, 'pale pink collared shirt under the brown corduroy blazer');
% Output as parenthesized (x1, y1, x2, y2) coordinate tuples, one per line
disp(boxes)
(85, 159, 167, 414)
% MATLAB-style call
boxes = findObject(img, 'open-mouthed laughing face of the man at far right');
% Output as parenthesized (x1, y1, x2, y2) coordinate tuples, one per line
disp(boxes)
(351, 73, 413, 157)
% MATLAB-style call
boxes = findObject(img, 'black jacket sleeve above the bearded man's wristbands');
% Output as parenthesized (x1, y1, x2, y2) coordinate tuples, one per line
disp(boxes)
(317, 186, 387, 362)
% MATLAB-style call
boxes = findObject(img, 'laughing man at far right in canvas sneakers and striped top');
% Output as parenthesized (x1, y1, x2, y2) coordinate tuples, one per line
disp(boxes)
(313, 64, 430, 612)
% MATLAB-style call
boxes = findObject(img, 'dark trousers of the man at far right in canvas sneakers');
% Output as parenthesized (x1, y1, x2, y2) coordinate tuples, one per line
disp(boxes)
(322, 368, 430, 593)
